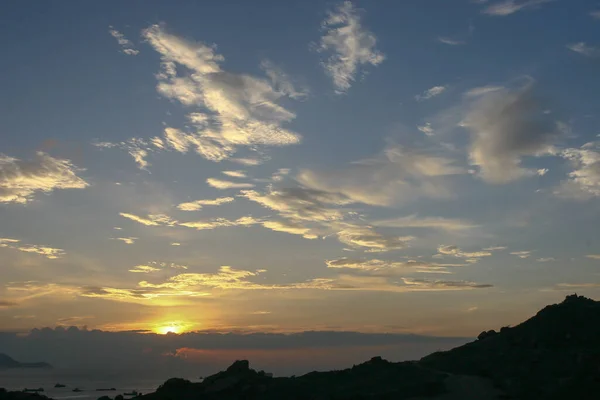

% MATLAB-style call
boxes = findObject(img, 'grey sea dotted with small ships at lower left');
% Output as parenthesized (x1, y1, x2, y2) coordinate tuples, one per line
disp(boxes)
(0, 369, 200, 400)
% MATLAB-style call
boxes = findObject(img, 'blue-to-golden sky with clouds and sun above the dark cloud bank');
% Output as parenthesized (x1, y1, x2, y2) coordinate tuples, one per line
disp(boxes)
(0, 0, 600, 366)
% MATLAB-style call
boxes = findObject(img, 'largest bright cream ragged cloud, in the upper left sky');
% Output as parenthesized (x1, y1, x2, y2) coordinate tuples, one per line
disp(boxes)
(143, 25, 300, 161)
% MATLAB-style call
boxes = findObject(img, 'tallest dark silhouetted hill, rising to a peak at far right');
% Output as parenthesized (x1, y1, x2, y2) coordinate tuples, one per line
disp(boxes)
(419, 295, 600, 399)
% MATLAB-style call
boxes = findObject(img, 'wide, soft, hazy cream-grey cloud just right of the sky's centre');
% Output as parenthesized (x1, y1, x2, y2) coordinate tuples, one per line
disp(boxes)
(297, 146, 467, 206)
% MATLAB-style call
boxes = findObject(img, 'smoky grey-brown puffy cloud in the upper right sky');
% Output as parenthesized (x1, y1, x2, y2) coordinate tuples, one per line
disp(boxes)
(460, 84, 560, 184)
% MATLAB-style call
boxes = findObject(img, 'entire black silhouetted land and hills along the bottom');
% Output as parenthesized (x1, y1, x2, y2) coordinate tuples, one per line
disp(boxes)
(0, 295, 600, 400)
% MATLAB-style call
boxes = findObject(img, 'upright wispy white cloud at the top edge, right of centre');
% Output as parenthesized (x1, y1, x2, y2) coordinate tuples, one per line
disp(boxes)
(318, 1, 385, 94)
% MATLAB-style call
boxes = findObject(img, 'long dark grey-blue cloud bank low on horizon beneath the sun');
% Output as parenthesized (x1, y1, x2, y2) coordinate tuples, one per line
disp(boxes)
(0, 327, 471, 377)
